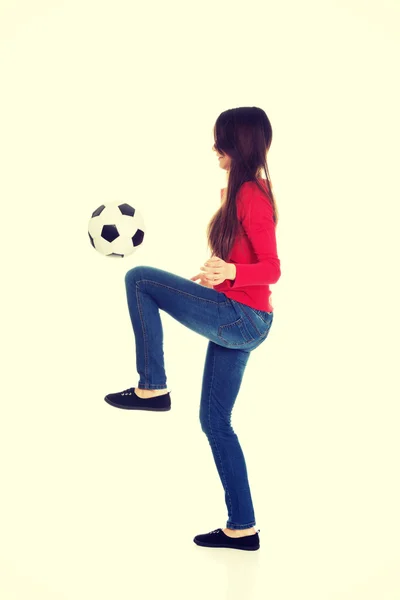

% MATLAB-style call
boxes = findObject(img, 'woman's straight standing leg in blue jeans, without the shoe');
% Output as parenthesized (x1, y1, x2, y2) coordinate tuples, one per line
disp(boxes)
(200, 341, 256, 529)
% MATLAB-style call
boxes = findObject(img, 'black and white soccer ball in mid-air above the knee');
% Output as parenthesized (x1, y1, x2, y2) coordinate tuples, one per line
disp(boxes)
(88, 202, 145, 258)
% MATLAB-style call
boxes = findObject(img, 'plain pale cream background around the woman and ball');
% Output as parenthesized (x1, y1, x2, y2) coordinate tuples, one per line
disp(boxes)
(0, 0, 400, 600)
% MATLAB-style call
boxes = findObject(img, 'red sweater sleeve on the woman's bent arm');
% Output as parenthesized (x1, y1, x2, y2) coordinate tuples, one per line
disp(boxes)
(230, 182, 281, 289)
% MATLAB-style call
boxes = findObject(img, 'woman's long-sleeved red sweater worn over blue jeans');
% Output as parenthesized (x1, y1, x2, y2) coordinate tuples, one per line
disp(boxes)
(214, 178, 281, 312)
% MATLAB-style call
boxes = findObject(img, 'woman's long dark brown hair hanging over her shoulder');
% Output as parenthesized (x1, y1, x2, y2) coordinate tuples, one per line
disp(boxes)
(207, 106, 278, 261)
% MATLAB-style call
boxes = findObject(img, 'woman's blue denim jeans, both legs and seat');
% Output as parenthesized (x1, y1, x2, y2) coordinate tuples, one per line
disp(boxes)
(125, 266, 273, 529)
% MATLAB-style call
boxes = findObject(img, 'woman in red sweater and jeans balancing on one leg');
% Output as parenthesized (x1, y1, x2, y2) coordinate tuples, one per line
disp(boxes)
(105, 107, 281, 550)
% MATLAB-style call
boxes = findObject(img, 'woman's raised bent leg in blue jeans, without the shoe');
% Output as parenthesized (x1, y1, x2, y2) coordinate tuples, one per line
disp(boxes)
(125, 266, 261, 390)
